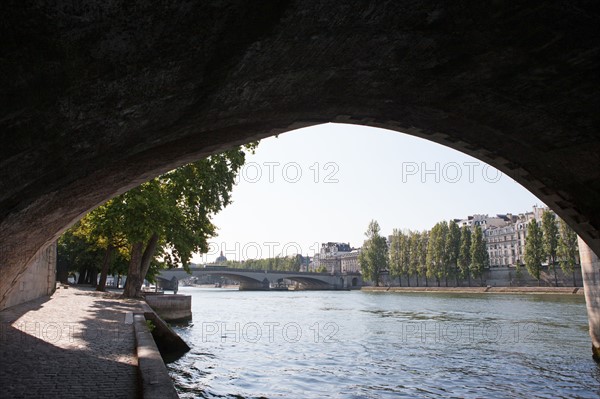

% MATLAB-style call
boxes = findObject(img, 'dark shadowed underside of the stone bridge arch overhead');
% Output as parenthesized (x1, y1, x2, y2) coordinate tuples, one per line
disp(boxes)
(0, 0, 600, 308)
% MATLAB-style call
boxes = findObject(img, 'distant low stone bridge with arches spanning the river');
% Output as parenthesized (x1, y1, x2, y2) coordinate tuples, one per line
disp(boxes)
(158, 267, 362, 290)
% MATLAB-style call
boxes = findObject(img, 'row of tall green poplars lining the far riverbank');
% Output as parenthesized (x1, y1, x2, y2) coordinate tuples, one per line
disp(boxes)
(359, 211, 578, 287)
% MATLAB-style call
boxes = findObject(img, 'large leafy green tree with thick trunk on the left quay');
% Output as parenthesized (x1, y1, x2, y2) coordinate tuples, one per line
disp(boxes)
(74, 143, 256, 297)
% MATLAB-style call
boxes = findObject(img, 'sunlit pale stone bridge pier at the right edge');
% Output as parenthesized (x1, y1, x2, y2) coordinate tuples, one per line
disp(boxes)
(578, 238, 600, 362)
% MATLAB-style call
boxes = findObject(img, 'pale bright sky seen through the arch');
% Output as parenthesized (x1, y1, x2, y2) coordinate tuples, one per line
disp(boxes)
(192, 123, 543, 263)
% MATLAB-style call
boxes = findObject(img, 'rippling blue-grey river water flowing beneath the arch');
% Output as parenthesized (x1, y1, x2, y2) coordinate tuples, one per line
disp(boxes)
(168, 288, 600, 398)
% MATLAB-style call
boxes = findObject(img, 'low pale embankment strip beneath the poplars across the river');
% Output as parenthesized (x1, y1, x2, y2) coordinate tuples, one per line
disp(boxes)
(361, 287, 583, 295)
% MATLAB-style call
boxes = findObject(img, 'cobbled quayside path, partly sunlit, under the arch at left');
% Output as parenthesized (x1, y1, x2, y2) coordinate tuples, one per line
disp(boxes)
(0, 287, 139, 398)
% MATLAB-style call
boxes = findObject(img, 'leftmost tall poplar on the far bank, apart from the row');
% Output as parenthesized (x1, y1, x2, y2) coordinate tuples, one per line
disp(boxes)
(358, 220, 388, 287)
